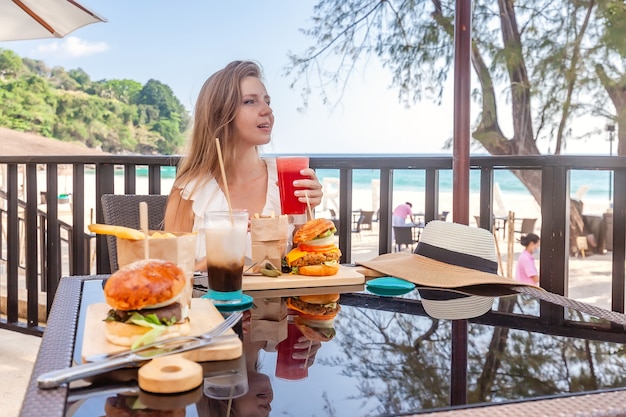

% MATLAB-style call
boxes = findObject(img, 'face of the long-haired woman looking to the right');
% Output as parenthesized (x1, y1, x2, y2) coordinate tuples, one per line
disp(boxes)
(234, 77, 274, 146)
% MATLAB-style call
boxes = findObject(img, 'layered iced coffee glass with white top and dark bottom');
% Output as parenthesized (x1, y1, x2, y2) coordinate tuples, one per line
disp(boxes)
(203, 210, 248, 304)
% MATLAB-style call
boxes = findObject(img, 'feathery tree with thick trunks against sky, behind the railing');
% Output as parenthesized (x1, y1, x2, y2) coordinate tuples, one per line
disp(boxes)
(286, 0, 626, 201)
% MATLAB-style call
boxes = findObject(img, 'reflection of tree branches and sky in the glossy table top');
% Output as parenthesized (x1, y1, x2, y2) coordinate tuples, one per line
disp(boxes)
(330, 296, 626, 415)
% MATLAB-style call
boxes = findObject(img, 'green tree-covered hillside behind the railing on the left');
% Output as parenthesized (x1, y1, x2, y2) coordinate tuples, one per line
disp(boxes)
(0, 48, 190, 154)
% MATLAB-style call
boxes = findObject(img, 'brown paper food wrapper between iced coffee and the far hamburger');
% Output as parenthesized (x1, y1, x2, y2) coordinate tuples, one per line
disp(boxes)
(250, 215, 289, 273)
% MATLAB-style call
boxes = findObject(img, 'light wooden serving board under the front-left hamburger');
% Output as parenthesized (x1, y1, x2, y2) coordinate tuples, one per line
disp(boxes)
(82, 298, 242, 362)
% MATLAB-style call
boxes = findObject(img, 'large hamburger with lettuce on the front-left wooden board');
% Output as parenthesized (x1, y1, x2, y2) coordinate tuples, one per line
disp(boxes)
(104, 259, 191, 349)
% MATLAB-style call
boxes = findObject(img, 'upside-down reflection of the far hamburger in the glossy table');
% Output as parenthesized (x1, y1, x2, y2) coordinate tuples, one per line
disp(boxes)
(287, 294, 340, 342)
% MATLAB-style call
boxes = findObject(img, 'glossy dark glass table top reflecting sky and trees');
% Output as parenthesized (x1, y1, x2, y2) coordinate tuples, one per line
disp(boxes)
(66, 281, 626, 417)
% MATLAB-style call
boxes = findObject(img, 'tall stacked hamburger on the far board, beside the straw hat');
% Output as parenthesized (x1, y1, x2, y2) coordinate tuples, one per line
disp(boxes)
(285, 219, 341, 276)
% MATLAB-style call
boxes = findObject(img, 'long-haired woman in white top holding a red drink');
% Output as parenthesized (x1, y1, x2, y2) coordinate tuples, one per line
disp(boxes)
(165, 61, 322, 269)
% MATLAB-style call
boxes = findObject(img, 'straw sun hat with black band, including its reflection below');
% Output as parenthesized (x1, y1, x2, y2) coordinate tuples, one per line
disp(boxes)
(359, 220, 523, 320)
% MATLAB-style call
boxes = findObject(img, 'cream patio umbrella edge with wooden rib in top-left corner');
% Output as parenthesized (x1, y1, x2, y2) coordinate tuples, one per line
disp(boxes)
(0, 0, 106, 41)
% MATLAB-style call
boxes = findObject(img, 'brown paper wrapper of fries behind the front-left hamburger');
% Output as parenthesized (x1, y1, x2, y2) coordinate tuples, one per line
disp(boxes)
(117, 230, 197, 306)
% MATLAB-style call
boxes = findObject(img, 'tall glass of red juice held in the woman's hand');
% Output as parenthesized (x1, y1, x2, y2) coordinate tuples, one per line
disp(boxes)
(276, 156, 309, 214)
